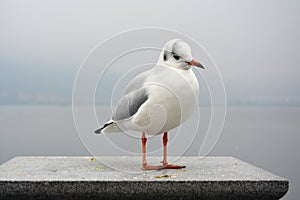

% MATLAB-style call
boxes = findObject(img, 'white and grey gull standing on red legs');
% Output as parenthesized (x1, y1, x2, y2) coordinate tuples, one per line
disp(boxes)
(95, 39, 204, 170)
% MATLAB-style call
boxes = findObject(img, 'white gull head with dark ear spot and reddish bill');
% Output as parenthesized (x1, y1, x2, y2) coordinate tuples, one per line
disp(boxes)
(159, 39, 204, 70)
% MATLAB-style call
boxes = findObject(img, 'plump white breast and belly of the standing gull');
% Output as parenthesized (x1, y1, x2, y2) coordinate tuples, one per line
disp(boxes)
(128, 66, 199, 134)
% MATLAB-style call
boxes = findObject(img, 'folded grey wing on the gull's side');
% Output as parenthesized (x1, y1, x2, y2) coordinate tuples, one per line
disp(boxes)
(113, 71, 149, 121)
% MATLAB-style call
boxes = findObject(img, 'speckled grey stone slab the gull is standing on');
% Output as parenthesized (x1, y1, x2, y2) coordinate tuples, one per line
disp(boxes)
(0, 157, 288, 199)
